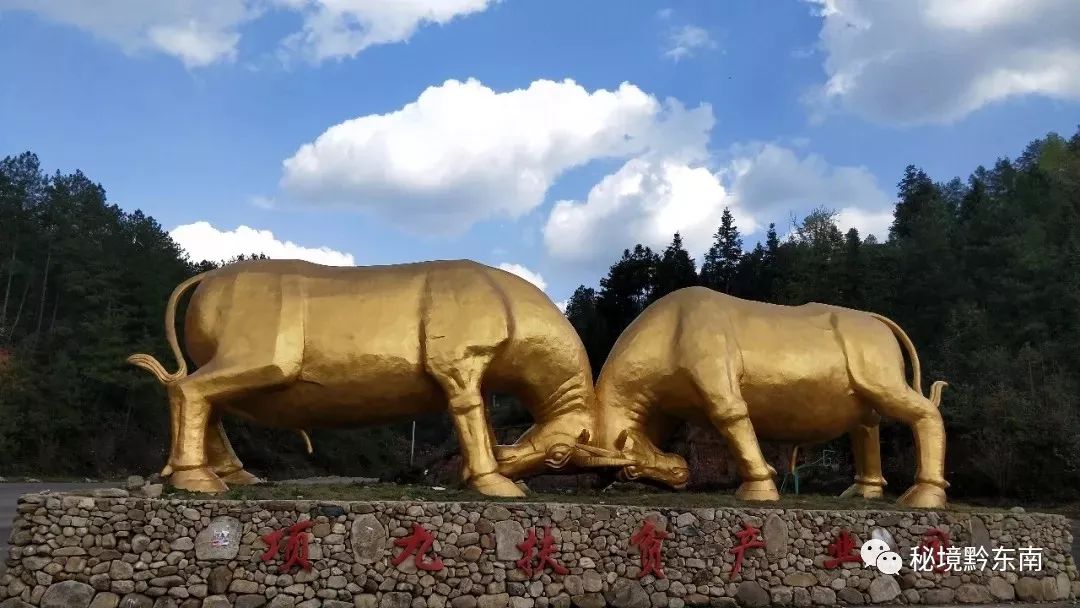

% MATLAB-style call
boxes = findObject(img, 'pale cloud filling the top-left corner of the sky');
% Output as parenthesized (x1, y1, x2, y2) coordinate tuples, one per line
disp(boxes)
(0, 0, 253, 68)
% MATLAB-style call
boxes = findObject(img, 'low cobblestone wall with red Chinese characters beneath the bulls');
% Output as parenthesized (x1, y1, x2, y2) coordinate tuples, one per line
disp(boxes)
(0, 490, 1080, 608)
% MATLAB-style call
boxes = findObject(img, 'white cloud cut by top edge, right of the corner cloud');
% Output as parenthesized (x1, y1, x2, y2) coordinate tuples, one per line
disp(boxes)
(276, 0, 498, 62)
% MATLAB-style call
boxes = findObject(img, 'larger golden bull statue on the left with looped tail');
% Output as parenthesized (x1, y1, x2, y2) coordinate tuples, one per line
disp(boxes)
(127, 260, 600, 496)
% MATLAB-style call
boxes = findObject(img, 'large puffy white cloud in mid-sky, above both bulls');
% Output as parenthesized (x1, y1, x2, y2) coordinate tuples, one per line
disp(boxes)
(282, 79, 713, 232)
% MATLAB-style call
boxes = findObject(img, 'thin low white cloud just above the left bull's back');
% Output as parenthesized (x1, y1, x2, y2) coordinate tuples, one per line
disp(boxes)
(168, 221, 355, 266)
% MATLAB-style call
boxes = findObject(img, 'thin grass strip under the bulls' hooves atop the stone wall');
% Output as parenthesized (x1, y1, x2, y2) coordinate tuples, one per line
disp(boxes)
(159, 483, 1019, 513)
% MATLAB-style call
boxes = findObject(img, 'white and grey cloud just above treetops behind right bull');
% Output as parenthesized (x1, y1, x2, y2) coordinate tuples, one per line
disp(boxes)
(543, 144, 892, 262)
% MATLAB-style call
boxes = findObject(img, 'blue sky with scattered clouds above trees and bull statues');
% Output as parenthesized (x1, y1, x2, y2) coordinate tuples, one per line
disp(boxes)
(0, 0, 1080, 301)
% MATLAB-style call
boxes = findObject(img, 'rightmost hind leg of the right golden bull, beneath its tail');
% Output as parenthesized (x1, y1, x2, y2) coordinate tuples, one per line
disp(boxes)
(875, 386, 948, 509)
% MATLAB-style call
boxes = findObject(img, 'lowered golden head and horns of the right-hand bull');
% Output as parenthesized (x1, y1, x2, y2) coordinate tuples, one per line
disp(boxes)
(567, 429, 690, 489)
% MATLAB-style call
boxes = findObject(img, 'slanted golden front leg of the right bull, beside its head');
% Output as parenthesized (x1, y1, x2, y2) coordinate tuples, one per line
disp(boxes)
(689, 361, 780, 500)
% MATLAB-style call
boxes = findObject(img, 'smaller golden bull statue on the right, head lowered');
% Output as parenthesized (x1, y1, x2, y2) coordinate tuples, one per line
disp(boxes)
(578, 287, 948, 508)
